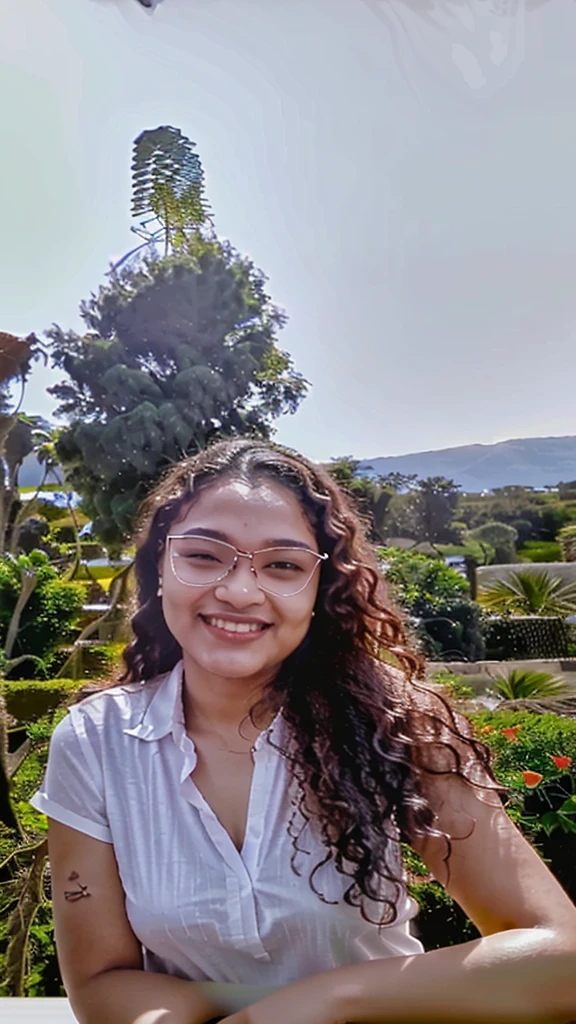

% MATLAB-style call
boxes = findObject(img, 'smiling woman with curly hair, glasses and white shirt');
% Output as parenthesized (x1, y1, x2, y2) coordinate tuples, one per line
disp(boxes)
(32, 440, 576, 1024)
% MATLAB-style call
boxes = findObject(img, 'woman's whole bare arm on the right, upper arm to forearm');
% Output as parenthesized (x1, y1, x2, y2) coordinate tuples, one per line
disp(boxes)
(218, 775, 576, 1024)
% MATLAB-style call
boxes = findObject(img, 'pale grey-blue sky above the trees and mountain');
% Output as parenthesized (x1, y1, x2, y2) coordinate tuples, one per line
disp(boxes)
(0, 0, 576, 460)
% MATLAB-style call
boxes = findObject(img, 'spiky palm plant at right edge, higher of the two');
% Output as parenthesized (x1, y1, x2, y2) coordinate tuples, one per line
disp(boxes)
(478, 570, 576, 617)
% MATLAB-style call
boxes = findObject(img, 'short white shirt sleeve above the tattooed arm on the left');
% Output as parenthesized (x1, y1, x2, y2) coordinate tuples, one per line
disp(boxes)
(29, 707, 112, 843)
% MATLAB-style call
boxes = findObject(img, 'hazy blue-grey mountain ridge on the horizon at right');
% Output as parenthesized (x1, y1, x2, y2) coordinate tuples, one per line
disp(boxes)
(360, 436, 576, 492)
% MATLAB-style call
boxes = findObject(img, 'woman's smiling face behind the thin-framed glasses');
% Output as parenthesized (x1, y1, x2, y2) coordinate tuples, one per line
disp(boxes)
(159, 480, 320, 685)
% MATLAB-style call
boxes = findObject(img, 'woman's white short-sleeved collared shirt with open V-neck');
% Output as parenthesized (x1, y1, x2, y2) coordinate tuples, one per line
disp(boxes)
(30, 662, 423, 985)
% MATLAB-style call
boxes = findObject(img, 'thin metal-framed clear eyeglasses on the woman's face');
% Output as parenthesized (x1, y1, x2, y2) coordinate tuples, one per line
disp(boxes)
(166, 534, 328, 597)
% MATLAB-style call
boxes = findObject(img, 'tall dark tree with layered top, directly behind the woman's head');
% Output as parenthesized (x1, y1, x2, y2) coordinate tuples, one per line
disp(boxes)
(47, 128, 307, 550)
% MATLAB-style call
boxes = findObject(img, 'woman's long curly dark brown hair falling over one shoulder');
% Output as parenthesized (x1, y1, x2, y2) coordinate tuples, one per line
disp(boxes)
(87, 439, 506, 926)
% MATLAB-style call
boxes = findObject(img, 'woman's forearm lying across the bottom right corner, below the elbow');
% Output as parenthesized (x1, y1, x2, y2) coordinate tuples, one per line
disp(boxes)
(217, 929, 576, 1024)
